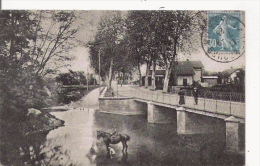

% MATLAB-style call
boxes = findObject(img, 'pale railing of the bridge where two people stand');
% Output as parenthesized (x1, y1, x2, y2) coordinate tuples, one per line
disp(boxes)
(119, 90, 245, 118)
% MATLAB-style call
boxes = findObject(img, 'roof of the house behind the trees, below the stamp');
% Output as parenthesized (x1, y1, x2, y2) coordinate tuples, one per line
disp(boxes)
(176, 60, 204, 75)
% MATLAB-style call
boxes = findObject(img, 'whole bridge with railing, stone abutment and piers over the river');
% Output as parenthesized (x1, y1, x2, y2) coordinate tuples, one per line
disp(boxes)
(99, 85, 245, 151)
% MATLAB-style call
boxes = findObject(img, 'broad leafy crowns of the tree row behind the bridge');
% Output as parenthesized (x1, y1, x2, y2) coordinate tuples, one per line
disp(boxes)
(90, 11, 205, 90)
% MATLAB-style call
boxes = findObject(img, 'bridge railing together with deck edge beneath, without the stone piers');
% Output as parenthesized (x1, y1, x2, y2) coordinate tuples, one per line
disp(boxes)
(118, 89, 245, 123)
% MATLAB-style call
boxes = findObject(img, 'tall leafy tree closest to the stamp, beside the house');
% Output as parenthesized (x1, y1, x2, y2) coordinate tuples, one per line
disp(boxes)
(157, 11, 203, 92)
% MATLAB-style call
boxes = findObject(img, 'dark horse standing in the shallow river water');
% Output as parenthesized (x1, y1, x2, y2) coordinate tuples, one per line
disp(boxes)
(97, 130, 130, 153)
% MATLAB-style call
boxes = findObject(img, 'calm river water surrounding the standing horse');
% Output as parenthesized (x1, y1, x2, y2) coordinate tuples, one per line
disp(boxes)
(0, 109, 244, 166)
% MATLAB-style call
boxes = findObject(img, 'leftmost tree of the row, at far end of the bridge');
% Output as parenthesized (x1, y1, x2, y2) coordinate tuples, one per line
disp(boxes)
(89, 11, 124, 88)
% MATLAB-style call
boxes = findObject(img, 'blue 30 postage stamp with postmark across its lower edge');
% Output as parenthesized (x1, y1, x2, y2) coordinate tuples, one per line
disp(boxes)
(202, 11, 245, 63)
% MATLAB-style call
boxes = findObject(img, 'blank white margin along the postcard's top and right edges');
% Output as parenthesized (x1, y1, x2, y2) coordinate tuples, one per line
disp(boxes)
(2, 0, 260, 166)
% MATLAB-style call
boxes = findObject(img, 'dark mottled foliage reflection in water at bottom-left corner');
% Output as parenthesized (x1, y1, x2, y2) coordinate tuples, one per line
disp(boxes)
(0, 132, 76, 166)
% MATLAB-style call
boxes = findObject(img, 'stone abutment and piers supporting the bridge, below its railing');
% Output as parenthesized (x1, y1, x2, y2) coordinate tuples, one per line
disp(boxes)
(99, 97, 245, 152)
